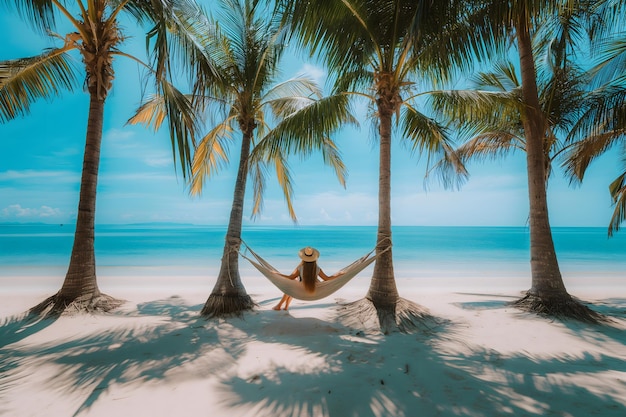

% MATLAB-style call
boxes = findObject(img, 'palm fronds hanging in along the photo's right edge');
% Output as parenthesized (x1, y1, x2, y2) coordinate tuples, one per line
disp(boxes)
(564, 1, 626, 236)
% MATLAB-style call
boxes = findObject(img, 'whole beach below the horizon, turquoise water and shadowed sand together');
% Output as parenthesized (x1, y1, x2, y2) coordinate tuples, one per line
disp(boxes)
(0, 225, 626, 417)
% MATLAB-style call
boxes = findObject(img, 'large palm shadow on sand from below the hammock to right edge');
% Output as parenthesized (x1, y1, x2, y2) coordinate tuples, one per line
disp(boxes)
(213, 300, 626, 417)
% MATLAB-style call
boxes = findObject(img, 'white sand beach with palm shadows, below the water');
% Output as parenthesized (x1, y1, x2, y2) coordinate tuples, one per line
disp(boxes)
(0, 270, 626, 417)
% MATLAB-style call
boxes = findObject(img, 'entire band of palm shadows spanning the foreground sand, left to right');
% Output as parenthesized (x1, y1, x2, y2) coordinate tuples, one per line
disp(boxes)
(0, 297, 626, 417)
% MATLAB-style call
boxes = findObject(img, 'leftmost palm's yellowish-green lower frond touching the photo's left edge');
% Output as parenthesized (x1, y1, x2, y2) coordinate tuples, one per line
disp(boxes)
(0, 47, 77, 121)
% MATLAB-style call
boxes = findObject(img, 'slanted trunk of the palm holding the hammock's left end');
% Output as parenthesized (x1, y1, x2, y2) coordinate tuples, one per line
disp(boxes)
(201, 130, 254, 317)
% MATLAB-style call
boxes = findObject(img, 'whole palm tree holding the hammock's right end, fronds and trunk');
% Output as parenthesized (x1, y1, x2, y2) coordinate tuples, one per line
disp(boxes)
(283, 0, 469, 332)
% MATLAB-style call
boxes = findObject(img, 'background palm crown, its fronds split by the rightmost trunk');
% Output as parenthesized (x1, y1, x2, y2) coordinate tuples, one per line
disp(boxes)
(430, 61, 587, 182)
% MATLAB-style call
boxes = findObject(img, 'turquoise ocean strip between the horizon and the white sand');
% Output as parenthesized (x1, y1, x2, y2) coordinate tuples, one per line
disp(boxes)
(0, 224, 626, 282)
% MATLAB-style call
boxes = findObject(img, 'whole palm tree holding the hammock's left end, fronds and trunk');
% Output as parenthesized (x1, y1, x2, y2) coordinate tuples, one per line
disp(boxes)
(131, 0, 356, 317)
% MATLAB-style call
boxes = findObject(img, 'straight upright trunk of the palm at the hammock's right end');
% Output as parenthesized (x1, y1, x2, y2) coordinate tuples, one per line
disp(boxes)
(367, 108, 400, 307)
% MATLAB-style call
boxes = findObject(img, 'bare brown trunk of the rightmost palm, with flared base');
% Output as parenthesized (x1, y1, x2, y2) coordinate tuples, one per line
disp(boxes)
(515, 19, 599, 321)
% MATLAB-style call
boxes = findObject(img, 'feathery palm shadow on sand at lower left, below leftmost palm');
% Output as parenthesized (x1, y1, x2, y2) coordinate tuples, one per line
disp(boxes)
(0, 297, 222, 416)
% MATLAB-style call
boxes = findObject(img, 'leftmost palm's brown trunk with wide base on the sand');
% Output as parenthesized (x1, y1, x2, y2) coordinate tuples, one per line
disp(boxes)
(31, 93, 122, 315)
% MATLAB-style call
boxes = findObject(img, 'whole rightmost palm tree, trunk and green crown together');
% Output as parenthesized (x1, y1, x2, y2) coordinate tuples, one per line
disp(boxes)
(434, 0, 599, 321)
